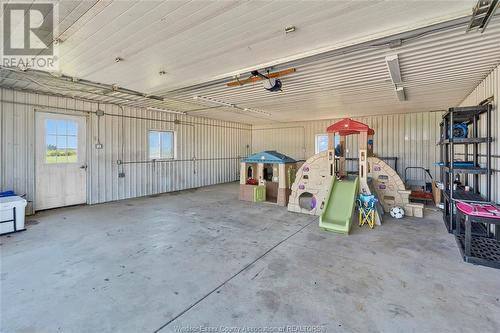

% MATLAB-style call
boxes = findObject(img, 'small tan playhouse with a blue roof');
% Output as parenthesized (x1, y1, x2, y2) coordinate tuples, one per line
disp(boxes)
(239, 150, 297, 206)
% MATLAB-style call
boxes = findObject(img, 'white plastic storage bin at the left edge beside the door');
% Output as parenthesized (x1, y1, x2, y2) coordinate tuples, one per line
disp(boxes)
(0, 196, 27, 235)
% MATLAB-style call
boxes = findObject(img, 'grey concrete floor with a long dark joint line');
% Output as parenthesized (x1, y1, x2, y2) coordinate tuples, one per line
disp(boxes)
(0, 184, 500, 332)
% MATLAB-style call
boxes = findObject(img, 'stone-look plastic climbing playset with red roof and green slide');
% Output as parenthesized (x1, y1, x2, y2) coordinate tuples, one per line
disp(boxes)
(288, 118, 423, 234)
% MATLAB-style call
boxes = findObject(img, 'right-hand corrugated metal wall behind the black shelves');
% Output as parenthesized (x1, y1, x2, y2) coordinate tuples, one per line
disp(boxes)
(461, 62, 500, 202)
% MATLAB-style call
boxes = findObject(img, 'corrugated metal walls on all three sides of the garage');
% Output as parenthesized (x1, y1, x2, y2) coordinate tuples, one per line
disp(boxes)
(0, 61, 500, 213)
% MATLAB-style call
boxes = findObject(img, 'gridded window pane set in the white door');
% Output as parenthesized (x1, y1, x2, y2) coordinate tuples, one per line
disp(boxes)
(45, 119, 78, 163)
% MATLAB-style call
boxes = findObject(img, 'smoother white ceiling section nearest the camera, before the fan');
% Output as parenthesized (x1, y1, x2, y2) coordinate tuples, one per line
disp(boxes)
(3, 0, 476, 93)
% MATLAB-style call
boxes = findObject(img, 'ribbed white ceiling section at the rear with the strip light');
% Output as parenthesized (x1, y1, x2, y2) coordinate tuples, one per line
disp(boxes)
(166, 17, 500, 121)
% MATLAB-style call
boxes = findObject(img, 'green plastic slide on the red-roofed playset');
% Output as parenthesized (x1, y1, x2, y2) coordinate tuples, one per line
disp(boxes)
(319, 177, 359, 235)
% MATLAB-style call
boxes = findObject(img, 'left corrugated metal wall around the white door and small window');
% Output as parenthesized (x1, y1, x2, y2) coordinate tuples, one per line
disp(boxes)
(0, 89, 251, 211)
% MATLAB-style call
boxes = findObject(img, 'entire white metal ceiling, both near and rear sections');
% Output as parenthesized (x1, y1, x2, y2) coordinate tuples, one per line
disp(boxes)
(0, 1, 500, 124)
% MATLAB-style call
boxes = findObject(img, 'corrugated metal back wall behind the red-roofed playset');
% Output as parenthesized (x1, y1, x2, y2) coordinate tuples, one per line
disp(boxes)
(252, 112, 443, 184)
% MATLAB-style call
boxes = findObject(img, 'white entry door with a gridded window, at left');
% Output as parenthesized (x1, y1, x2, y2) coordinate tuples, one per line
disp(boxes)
(35, 112, 87, 210)
